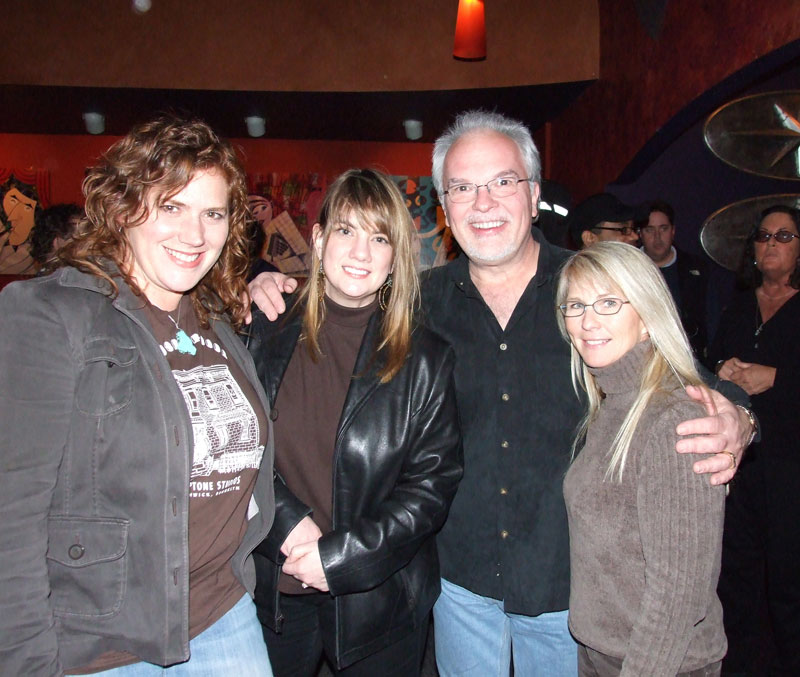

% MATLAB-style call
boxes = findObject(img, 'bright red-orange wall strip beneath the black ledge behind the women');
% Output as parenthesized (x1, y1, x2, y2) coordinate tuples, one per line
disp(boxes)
(0, 134, 432, 204)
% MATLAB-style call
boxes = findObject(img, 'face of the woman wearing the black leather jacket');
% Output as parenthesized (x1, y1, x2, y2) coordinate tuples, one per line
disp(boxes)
(312, 214, 394, 308)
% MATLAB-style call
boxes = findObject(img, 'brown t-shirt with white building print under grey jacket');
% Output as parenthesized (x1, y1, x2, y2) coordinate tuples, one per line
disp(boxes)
(147, 298, 267, 637)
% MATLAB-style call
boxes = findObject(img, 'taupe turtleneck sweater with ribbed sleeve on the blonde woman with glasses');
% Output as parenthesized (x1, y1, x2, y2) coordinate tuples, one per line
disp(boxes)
(564, 341, 727, 676)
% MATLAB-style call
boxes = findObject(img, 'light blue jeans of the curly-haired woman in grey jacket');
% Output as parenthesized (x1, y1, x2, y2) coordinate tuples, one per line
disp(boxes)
(95, 594, 272, 677)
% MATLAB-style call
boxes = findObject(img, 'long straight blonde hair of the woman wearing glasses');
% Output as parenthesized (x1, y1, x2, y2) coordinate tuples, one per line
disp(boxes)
(556, 242, 705, 481)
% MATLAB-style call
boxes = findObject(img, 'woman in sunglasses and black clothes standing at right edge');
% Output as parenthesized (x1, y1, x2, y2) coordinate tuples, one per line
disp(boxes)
(709, 205, 800, 675)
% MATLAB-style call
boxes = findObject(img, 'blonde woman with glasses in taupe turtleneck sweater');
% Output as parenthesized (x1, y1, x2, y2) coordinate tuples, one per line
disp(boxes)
(557, 242, 726, 676)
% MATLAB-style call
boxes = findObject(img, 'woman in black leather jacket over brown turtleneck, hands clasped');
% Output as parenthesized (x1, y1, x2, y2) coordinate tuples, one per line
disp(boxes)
(249, 170, 462, 676)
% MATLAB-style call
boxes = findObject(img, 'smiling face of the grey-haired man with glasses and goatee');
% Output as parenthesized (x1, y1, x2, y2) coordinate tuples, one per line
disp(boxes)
(443, 131, 539, 267)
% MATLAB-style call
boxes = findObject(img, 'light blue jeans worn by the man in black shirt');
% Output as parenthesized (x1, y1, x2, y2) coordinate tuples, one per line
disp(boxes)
(433, 579, 578, 677)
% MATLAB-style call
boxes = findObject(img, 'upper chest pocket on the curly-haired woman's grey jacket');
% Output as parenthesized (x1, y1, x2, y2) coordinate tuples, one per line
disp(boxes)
(75, 338, 139, 416)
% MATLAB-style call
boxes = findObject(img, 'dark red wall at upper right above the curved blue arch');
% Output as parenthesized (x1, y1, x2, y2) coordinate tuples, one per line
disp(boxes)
(550, 0, 800, 199)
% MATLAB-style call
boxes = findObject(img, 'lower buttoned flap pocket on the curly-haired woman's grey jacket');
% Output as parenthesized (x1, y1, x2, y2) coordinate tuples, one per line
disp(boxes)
(47, 516, 130, 617)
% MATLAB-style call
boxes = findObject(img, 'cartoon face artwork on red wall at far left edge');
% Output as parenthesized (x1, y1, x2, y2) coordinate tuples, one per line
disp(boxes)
(0, 168, 50, 275)
